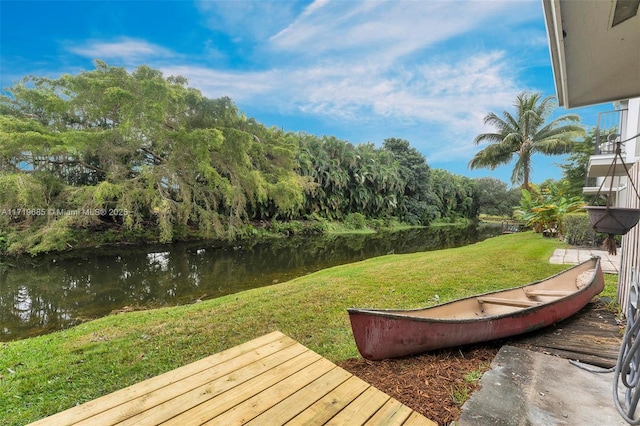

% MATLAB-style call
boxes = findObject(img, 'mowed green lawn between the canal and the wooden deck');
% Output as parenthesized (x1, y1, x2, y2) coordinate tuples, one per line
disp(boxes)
(0, 233, 615, 425)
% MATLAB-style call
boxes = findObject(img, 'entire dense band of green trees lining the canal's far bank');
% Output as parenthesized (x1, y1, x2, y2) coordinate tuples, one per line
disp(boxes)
(0, 61, 478, 254)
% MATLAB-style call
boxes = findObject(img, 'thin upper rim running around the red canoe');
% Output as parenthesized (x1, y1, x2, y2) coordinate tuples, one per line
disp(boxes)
(347, 256, 600, 324)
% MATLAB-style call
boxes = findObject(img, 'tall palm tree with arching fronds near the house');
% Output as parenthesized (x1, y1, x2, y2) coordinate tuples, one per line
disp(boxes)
(469, 92, 584, 188)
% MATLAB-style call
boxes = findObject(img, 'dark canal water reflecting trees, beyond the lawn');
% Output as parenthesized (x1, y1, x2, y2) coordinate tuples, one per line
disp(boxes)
(0, 225, 501, 341)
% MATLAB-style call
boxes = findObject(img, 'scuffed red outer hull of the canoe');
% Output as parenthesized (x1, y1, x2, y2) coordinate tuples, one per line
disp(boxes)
(348, 258, 604, 360)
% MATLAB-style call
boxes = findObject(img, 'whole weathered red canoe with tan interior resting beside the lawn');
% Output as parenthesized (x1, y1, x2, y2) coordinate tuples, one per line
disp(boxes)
(347, 257, 604, 360)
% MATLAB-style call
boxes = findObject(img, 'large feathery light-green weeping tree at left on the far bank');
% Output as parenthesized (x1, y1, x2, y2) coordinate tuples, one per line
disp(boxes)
(0, 61, 304, 252)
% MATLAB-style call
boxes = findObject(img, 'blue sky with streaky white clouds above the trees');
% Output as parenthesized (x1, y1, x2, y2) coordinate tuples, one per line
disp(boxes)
(0, 0, 613, 183)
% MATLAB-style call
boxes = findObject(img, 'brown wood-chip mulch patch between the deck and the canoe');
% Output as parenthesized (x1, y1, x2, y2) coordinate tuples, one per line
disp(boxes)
(338, 344, 500, 425)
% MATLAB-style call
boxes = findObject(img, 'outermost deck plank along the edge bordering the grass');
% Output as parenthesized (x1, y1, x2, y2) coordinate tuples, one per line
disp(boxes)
(27, 331, 296, 426)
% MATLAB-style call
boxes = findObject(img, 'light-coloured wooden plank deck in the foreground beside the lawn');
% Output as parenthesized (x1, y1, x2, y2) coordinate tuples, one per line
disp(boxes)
(32, 332, 436, 426)
